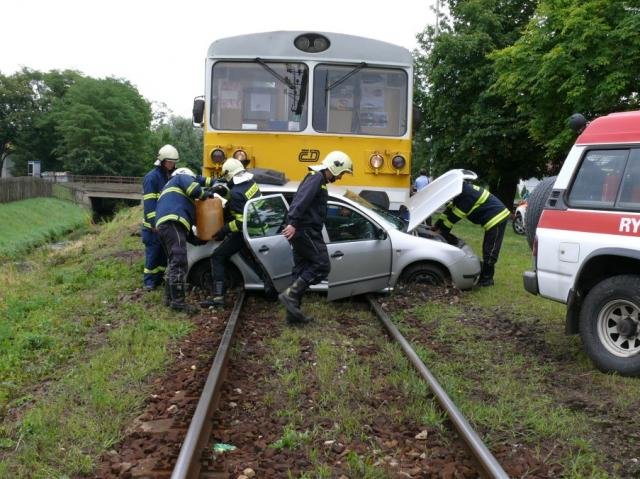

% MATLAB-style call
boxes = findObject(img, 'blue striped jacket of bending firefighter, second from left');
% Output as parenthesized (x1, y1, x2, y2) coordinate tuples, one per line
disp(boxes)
(156, 175, 213, 231)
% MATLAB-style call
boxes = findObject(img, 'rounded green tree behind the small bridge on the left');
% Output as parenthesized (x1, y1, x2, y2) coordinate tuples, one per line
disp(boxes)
(53, 78, 151, 176)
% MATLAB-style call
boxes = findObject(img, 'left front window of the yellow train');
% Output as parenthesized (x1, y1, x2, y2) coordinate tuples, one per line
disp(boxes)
(209, 59, 309, 131)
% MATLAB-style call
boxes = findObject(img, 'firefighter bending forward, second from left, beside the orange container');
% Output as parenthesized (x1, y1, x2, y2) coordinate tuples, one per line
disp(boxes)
(156, 168, 213, 313)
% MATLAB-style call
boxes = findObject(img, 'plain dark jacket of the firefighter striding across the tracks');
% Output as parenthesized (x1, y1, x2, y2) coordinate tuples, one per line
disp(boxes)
(287, 170, 329, 231)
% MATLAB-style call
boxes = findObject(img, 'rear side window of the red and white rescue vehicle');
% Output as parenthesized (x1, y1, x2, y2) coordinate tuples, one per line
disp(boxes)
(568, 149, 629, 208)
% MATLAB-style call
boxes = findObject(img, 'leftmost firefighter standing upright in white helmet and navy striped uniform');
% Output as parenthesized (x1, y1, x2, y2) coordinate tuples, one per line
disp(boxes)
(142, 145, 180, 291)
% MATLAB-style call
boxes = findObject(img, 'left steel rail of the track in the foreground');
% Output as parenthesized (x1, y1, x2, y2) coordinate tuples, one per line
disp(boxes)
(171, 291, 245, 479)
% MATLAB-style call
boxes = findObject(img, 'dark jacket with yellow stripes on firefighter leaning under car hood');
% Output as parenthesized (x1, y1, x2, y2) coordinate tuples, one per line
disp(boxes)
(438, 182, 509, 232)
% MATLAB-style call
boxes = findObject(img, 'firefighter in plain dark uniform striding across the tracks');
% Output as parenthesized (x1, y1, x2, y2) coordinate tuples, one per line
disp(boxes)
(278, 151, 353, 324)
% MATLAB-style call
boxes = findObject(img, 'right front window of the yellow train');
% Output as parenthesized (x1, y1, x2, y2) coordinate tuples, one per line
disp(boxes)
(313, 64, 408, 136)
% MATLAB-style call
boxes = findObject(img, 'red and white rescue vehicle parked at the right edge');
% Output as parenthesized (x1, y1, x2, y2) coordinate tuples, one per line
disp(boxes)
(524, 111, 640, 376)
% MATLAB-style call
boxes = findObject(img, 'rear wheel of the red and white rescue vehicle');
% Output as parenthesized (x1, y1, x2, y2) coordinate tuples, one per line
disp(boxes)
(580, 275, 640, 376)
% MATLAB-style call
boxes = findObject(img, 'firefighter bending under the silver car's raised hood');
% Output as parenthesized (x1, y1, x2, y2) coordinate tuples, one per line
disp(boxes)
(434, 181, 510, 286)
